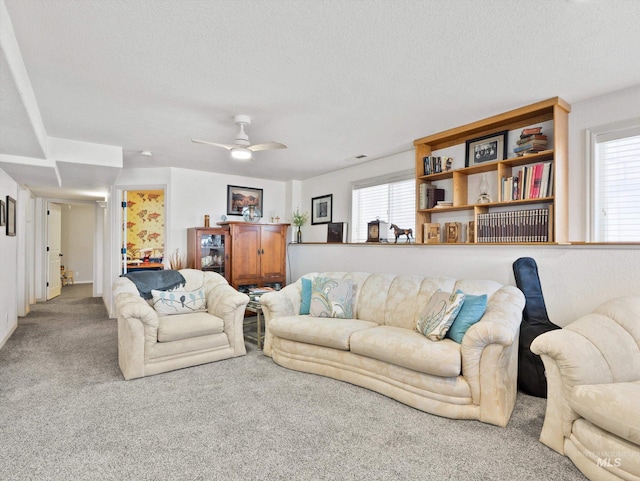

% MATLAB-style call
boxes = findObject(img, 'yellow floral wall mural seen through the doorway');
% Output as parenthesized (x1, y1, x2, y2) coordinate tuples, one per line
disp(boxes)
(127, 190, 164, 259)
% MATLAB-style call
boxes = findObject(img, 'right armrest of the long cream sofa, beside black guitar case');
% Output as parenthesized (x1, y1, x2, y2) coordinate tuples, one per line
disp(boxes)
(460, 286, 525, 426)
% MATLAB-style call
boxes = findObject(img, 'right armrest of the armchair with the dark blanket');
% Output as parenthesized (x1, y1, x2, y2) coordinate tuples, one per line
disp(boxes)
(206, 284, 249, 355)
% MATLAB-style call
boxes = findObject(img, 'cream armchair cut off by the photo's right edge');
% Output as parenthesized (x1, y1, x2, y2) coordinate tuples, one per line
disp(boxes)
(531, 297, 640, 481)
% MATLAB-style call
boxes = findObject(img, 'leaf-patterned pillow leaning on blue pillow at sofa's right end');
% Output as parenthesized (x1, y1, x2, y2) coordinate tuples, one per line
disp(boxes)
(416, 289, 464, 341)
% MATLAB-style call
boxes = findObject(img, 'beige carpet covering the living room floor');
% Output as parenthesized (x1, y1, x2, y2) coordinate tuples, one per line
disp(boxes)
(0, 284, 585, 481)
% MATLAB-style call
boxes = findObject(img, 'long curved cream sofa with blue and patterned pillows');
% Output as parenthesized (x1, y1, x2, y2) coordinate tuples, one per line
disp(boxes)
(262, 272, 525, 426)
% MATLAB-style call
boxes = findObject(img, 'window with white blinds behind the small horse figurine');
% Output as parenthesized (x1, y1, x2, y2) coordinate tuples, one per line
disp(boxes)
(351, 171, 416, 242)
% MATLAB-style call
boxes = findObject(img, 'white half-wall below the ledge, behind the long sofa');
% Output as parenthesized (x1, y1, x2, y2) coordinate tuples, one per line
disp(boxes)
(288, 244, 640, 326)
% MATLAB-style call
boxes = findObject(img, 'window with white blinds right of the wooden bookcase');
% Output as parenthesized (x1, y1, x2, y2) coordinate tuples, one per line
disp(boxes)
(590, 119, 640, 242)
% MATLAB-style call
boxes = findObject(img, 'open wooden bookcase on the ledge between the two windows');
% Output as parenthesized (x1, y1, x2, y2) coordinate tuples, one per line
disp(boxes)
(414, 97, 571, 243)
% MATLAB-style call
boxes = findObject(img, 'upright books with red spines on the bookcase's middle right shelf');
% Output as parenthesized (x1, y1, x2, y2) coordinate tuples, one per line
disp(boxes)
(501, 161, 553, 201)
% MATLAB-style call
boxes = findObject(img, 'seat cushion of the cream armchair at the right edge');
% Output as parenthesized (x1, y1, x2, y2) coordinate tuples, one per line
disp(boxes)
(569, 381, 640, 444)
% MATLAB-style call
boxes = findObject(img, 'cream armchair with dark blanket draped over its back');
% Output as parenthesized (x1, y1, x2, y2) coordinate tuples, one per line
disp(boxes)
(113, 269, 249, 380)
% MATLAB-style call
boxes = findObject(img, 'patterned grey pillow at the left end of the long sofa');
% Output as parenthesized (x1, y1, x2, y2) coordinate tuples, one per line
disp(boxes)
(309, 277, 353, 319)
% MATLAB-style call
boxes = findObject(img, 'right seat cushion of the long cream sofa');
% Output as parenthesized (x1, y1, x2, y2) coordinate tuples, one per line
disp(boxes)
(351, 326, 462, 377)
